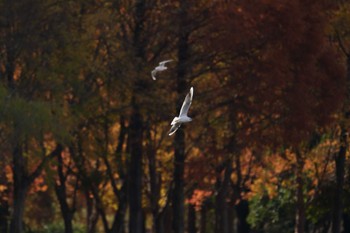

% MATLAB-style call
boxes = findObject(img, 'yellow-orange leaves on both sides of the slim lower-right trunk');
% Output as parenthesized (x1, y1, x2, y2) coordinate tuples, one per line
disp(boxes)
(244, 136, 339, 203)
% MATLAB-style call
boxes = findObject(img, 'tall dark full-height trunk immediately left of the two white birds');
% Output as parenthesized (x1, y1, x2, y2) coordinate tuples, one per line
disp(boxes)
(128, 0, 146, 229)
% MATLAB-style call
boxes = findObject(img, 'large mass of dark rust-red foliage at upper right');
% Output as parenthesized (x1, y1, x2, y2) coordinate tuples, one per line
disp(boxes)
(209, 0, 345, 145)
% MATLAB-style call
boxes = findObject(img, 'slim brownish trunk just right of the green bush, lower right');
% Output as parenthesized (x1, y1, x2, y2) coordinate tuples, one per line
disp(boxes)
(294, 151, 305, 233)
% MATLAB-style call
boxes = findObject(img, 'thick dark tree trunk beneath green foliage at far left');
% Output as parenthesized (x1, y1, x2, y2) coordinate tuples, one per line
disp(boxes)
(10, 145, 29, 233)
